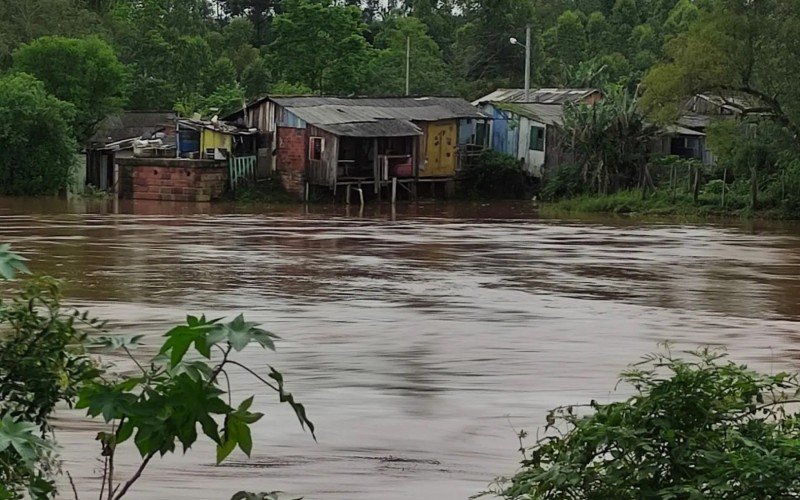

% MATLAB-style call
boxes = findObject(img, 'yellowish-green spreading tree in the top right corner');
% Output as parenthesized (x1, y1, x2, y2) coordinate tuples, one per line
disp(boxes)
(642, 0, 800, 141)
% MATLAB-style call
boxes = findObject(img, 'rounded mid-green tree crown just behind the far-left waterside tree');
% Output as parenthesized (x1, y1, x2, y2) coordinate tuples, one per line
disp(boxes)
(13, 36, 126, 144)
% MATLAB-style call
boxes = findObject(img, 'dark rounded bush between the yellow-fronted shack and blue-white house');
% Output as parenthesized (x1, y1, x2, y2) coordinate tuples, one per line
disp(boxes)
(459, 150, 535, 199)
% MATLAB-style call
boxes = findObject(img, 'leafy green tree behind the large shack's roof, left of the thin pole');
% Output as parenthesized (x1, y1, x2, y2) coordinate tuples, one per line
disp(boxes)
(270, 0, 372, 94)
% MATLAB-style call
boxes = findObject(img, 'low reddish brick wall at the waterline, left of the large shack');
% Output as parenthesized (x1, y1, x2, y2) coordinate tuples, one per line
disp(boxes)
(122, 158, 228, 202)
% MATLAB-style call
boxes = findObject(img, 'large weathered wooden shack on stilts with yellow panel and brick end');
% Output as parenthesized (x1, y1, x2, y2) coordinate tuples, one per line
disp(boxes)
(227, 97, 488, 196)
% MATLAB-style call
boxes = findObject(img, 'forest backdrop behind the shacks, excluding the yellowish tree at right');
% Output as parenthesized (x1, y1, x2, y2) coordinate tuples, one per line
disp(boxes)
(0, 0, 720, 109)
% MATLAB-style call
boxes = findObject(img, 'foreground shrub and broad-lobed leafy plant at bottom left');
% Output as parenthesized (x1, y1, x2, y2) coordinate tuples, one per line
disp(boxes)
(0, 245, 314, 500)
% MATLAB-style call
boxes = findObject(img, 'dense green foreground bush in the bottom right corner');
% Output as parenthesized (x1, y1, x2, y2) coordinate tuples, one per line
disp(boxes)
(488, 349, 800, 500)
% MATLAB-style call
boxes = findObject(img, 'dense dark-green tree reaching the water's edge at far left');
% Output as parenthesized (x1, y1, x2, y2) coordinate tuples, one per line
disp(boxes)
(0, 74, 76, 196)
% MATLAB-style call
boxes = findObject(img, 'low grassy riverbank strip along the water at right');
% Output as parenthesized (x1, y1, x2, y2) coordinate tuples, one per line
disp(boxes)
(540, 189, 800, 220)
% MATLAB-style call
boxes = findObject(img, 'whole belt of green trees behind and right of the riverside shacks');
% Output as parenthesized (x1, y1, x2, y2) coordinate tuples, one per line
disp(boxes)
(0, 0, 800, 207)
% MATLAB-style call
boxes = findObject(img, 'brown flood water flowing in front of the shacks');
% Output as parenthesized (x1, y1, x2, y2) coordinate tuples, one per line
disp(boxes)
(0, 199, 800, 500)
